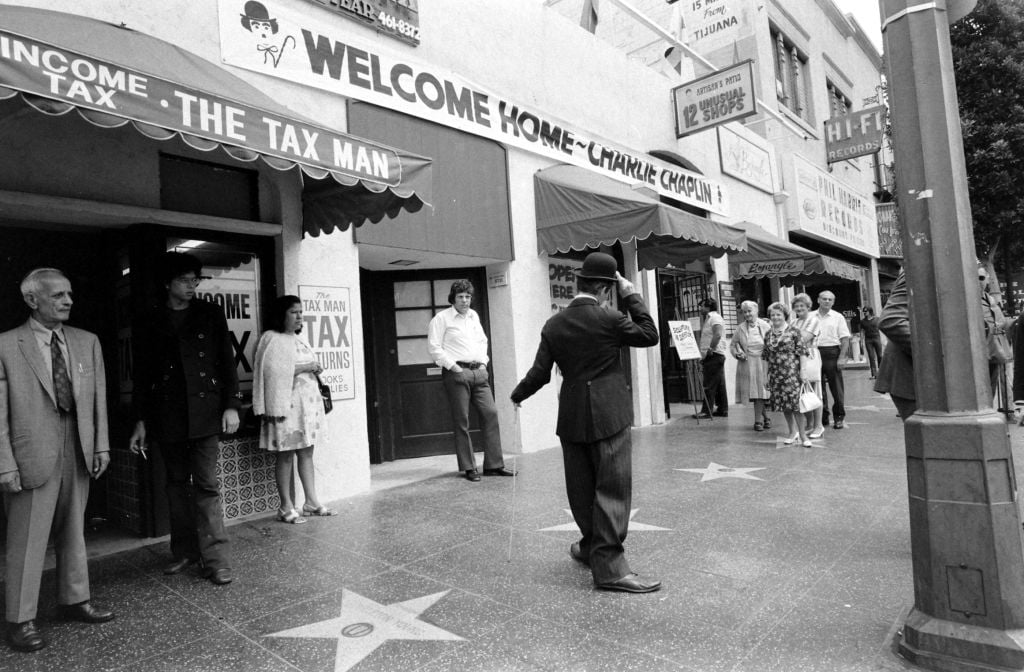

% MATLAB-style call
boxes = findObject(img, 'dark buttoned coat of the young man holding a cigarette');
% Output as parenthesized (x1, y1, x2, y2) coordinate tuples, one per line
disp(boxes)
(133, 299, 242, 442)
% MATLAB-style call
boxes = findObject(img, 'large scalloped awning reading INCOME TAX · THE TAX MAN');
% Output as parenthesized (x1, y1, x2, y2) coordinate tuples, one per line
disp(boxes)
(0, 6, 431, 229)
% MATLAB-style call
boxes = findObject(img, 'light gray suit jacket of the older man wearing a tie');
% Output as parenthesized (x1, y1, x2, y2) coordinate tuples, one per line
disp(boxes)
(0, 322, 111, 490)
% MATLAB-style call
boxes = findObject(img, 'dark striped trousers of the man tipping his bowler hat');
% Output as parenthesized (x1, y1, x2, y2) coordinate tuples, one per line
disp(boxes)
(561, 427, 633, 584)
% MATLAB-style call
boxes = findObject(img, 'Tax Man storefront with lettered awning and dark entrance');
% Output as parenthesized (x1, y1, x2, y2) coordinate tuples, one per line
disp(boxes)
(0, 6, 432, 536)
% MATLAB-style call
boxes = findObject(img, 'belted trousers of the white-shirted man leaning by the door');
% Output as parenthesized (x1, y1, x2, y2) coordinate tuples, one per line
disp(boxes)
(441, 367, 505, 471)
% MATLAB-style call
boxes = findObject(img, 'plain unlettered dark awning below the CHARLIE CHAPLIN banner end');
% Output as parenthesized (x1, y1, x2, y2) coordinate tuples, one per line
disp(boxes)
(534, 165, 746, 268)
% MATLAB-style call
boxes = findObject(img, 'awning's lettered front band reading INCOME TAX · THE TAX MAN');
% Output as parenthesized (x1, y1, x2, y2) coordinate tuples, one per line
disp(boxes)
(0, 27, 401, 186)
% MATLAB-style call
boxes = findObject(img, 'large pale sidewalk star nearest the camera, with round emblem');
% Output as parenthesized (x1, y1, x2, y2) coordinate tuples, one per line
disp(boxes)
(265, 590, 462, 672)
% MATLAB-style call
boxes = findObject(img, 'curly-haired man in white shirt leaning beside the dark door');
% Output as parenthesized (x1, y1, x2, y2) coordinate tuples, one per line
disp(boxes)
(427, 280, 514, 482)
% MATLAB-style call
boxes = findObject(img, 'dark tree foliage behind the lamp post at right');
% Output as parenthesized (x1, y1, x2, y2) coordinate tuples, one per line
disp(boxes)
(949, 0, 1024, 261)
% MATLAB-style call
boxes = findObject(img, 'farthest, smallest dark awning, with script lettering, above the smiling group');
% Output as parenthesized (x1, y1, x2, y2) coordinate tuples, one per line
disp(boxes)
(729, 221, 863, 281)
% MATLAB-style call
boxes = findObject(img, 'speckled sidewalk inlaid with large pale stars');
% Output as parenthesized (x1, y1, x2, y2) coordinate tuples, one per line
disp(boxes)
(0, 371, 999, 672)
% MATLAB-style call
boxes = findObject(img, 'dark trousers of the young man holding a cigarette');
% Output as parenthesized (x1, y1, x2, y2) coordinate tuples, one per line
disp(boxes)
(161, 434, 230, 570)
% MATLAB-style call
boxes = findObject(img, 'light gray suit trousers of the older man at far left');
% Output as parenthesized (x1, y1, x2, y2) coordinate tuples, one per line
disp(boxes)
(4, 413, 89, 623)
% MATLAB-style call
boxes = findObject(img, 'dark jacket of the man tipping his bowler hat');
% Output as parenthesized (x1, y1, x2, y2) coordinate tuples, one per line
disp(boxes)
(512, 294, 657, 443)
